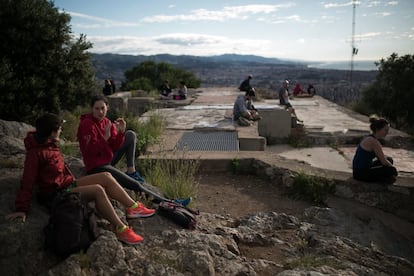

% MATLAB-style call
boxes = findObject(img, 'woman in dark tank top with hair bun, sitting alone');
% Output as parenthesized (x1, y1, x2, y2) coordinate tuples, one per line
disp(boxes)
(352, 115, 398, 184)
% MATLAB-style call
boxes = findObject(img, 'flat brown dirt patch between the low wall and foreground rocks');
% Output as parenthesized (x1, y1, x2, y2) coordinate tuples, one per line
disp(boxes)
(195, 173, 311, 218)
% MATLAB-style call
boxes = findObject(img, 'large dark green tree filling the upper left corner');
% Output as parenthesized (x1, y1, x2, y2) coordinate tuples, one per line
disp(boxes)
(0, 0, 96, 123)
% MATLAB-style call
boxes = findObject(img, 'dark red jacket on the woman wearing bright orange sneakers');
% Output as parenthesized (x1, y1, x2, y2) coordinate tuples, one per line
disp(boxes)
(15, 131, 75, 212)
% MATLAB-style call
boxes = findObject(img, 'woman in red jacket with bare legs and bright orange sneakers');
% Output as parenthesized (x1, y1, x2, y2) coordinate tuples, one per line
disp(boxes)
(7, 114, 155, 244)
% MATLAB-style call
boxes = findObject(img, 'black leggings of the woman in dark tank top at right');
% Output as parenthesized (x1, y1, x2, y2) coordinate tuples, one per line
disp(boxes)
(353, 157, 398, 182)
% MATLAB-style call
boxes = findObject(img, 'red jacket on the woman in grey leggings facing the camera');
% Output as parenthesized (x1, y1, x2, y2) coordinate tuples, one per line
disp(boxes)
(77, 113, 125, 171)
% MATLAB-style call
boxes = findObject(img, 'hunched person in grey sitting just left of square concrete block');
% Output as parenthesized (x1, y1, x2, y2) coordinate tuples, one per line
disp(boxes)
(233, 89, 261, 126)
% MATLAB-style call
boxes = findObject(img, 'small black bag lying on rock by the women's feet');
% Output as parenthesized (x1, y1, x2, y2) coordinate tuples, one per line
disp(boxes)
(158, 201, 200, 230)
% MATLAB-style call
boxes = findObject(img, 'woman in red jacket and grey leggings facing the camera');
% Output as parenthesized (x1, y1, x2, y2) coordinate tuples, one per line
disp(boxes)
(77, 95, 191, 205)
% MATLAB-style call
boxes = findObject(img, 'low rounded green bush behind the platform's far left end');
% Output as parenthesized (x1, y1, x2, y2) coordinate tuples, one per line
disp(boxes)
(122, 61, 200, 91)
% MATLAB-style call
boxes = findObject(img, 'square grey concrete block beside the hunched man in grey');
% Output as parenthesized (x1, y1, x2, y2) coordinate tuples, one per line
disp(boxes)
(258, 108, 292, 140)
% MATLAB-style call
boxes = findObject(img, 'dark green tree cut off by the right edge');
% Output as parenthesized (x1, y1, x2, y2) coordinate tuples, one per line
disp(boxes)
(362, 53, 414, 130)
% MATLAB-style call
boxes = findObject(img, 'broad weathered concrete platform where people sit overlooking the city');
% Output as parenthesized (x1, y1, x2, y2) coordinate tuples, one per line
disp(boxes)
(141, 88, 414, 187)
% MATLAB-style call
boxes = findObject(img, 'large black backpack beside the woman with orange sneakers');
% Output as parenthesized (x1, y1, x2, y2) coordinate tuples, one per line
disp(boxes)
(44, 192, 99, 257)
